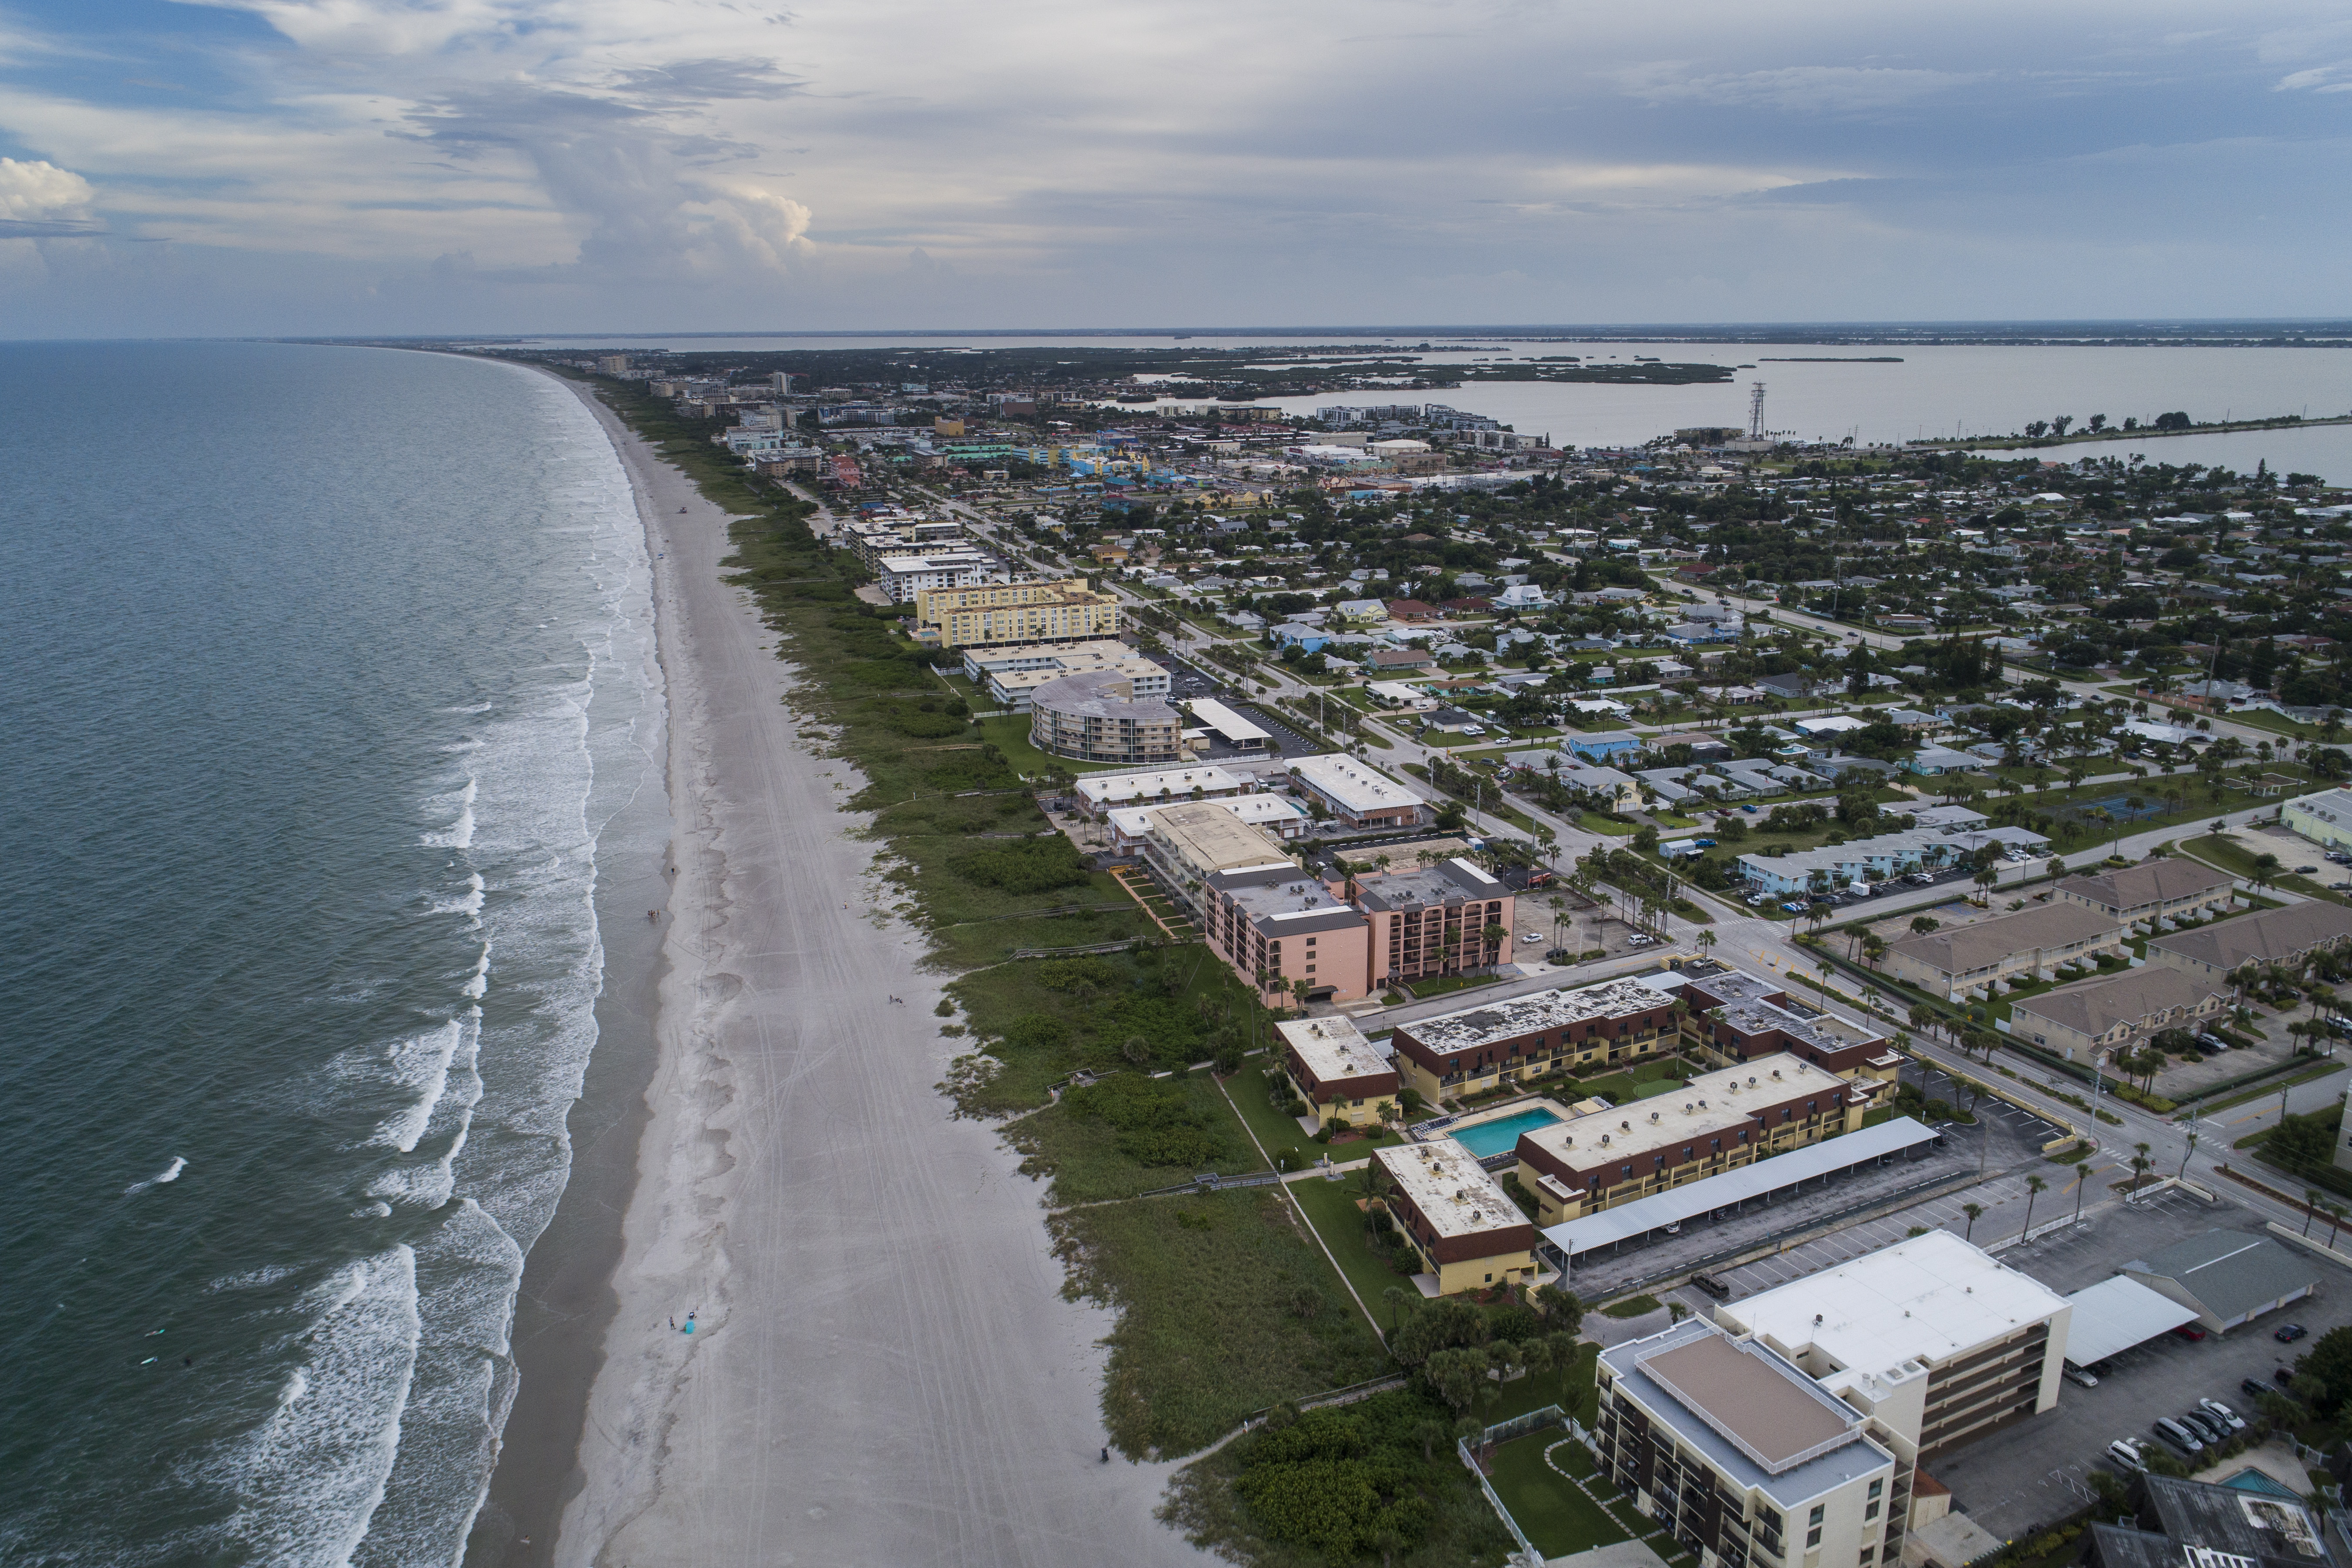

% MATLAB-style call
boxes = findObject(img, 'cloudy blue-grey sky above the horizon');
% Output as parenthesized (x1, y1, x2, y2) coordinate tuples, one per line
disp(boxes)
(0, 0, 2352, 338)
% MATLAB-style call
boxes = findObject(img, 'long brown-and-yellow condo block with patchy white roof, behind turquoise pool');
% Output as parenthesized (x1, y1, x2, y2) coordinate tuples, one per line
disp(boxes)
(1390, 978, 1675, 1105)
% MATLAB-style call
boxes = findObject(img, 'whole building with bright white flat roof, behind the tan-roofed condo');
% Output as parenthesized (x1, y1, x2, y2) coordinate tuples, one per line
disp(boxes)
(1714, 1230, 2072, 1460)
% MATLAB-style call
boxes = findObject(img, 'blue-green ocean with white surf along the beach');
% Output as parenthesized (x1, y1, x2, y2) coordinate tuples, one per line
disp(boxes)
(0, 343, 663, 1563)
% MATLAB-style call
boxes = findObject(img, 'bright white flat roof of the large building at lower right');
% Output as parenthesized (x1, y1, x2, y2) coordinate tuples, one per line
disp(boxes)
(1714, 1230, 2065, 1373)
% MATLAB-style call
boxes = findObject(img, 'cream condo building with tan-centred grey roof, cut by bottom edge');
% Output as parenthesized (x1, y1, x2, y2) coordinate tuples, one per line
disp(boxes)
(1592, 1319, 1912, 1568)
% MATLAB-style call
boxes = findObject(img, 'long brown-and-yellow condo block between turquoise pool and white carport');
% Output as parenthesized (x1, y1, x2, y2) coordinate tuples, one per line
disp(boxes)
(1515, 1053, 1872, 1227)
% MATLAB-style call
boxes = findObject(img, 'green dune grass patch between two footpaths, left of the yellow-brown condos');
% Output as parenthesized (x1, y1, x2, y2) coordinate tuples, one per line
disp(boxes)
(1051, 1187, 1388, 1457)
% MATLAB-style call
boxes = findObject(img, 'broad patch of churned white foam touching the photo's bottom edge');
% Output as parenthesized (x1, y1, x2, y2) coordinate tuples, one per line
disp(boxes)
(228, 1246, 423, 1568)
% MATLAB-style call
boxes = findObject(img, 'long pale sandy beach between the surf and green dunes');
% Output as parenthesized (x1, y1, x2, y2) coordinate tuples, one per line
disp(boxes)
(531, 393, 1204, 1568)
